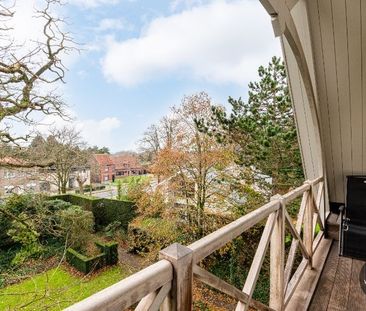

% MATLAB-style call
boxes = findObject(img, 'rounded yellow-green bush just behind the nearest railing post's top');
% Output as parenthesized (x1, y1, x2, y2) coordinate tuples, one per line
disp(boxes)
(128, 218, 179, 254)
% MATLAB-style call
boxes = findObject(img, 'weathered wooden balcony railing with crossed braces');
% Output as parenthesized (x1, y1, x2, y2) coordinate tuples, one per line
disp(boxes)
(67, 177, 324, 311)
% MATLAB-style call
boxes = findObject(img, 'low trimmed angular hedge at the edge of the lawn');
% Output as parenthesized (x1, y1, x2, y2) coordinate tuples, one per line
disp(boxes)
(66, 242, 118, 274)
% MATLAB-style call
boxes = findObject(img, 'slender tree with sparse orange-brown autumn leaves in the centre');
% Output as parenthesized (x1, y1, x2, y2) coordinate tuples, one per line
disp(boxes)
(152, 92, 233, 235)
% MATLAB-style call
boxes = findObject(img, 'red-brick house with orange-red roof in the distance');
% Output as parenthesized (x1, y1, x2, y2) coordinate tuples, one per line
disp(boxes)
(93, 154, 147, 182)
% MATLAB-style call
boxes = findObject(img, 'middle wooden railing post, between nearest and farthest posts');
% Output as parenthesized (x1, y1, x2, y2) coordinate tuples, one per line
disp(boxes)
(269, 195, 285, 311)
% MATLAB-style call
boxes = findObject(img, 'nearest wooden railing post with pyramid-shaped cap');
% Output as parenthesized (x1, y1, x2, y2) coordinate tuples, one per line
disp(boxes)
(159, 243, 193, 311)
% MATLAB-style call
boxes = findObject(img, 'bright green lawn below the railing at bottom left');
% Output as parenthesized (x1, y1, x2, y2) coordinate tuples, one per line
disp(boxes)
(0, 266, 128, 310)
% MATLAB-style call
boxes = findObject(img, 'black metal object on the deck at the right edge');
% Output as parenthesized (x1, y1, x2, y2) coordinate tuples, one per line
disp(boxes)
(339, 176, 366, 260)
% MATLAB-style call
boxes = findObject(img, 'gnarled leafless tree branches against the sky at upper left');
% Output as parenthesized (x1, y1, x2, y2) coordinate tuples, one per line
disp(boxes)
(0, 0, 75, 147)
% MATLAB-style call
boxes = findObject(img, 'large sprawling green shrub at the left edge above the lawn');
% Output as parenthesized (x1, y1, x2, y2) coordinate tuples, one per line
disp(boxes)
(0, 194, 94, 265)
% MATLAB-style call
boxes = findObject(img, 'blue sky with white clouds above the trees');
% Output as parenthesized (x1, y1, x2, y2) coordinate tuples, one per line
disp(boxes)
(10, 0, 281, 152)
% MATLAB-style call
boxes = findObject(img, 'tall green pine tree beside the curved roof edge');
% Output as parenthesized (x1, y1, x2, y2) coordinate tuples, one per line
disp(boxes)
(197, 57, 303, 193)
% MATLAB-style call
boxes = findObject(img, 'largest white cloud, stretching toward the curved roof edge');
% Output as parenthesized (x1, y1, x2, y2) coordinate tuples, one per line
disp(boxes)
(102, 0, 280, 86)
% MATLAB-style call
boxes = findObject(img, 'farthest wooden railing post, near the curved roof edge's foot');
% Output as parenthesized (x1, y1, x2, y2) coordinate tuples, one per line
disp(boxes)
(304, 181, 314, 269)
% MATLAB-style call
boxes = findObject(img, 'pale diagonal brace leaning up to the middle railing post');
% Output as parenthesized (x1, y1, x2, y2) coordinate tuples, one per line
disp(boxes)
(235, 211, 278, 311)
